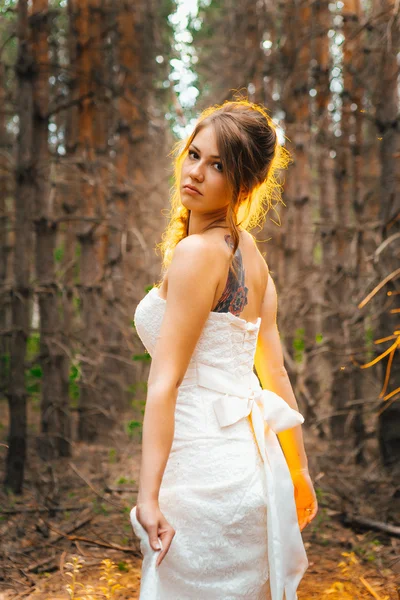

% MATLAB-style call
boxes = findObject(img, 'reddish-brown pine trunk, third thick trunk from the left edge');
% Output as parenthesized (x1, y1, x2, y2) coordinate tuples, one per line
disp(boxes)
(70, 0, 113, 442)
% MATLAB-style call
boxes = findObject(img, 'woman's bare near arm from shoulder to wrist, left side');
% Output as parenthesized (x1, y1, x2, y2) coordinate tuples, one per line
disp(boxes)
(137, 234, 224, 507)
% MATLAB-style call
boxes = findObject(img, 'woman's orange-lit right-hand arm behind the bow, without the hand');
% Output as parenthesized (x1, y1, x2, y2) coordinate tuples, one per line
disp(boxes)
(254, 274, 308, 472)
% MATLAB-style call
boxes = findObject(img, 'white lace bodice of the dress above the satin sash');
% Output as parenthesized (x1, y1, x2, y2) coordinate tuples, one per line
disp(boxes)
(134, 287, 261, 381)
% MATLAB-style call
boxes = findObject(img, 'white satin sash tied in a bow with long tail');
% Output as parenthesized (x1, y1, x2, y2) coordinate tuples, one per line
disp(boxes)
(195, 362, 308, 600)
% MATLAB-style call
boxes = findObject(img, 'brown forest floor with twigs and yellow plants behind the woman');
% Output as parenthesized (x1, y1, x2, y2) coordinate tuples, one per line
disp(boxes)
(0, 407, 400, 600)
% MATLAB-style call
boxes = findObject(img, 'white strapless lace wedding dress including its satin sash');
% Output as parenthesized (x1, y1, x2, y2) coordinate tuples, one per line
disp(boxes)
(131, 287, 308, 600)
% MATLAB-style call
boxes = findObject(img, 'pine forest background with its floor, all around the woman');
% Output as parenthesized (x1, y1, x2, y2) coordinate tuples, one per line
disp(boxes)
(0, 0, 400, 600)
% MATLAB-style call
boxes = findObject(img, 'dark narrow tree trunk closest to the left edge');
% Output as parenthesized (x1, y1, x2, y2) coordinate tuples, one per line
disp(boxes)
(5, 0, 34, 494)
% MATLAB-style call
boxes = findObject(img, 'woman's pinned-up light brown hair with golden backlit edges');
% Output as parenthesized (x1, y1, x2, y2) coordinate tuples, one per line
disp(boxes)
(156, 99, 291, 282)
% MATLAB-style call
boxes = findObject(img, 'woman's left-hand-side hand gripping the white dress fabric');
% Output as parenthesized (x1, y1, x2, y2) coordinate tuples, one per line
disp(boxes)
(136, 502, 175, 567)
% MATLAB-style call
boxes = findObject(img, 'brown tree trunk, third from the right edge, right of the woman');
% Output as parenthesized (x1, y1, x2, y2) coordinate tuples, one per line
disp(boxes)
(303, 1, 334, 438)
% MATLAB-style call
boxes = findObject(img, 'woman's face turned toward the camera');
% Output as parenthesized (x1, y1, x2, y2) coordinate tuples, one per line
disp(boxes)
(180, 125, 231, 213)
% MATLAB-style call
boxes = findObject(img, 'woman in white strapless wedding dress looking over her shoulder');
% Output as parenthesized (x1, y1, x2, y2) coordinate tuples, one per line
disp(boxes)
(131, 100, 317, 600)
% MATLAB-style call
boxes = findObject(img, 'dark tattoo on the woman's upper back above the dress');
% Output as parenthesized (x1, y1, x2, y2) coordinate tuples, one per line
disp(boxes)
(212, 233, 248, 316)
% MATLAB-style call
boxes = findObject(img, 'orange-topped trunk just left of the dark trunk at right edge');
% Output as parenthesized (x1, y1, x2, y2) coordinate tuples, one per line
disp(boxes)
(326, 0, 362, 441)
